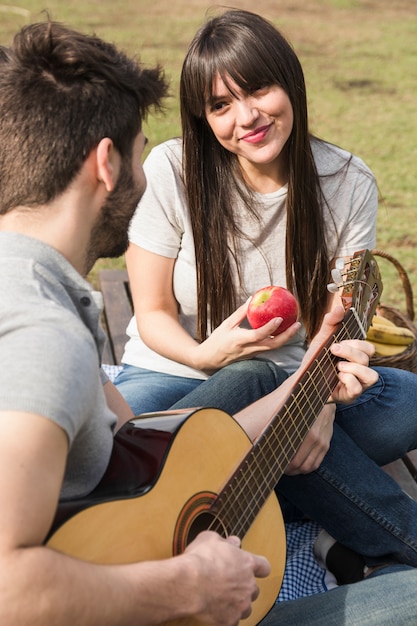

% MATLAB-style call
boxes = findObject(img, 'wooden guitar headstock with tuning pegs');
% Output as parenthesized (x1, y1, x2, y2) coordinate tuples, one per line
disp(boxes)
(328, 250, 382, 334)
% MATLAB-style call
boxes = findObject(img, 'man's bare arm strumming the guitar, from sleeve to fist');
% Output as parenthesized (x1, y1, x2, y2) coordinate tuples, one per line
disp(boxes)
(0, 411, 269, 626)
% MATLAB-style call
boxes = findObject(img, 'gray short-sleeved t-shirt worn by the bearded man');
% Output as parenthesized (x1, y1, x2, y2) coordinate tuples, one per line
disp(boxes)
(0, 232, 116, 499)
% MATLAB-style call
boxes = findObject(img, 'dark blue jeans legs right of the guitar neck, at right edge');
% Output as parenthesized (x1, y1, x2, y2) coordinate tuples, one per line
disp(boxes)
(276, 368, 417, 567)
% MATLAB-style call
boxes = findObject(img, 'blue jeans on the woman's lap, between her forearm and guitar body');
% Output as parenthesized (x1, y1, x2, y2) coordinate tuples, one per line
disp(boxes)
(114, 359, 287, 415)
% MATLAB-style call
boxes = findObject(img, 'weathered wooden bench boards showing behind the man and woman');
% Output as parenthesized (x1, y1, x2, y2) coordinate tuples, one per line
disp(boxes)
(98, 270, 417, 500)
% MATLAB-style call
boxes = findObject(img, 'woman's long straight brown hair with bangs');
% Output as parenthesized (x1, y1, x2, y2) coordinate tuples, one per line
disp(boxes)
(180, 10, 330, 341)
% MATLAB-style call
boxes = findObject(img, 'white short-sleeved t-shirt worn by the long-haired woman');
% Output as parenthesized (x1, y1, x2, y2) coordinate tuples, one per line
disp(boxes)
(122, 139, 378, 379)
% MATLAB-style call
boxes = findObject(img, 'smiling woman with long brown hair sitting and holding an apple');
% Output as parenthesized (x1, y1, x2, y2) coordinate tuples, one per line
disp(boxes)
(116, 10, 417, 566)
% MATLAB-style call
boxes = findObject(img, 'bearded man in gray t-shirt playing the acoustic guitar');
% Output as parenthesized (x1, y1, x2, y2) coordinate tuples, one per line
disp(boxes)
(0, 21, 412, 626)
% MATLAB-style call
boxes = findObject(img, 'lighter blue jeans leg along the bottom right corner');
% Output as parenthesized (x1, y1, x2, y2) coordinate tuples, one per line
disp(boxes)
(260, 569, 417, 626)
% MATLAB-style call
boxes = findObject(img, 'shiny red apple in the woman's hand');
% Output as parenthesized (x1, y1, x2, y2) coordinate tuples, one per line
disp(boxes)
(247, 285, 298, 335)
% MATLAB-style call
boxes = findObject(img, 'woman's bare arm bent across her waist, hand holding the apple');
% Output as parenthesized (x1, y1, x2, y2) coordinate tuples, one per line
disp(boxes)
(126, 244, 300, 372)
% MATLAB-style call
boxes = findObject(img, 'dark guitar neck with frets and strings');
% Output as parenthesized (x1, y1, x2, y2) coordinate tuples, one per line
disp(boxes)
(213, 309, 364, 537)
